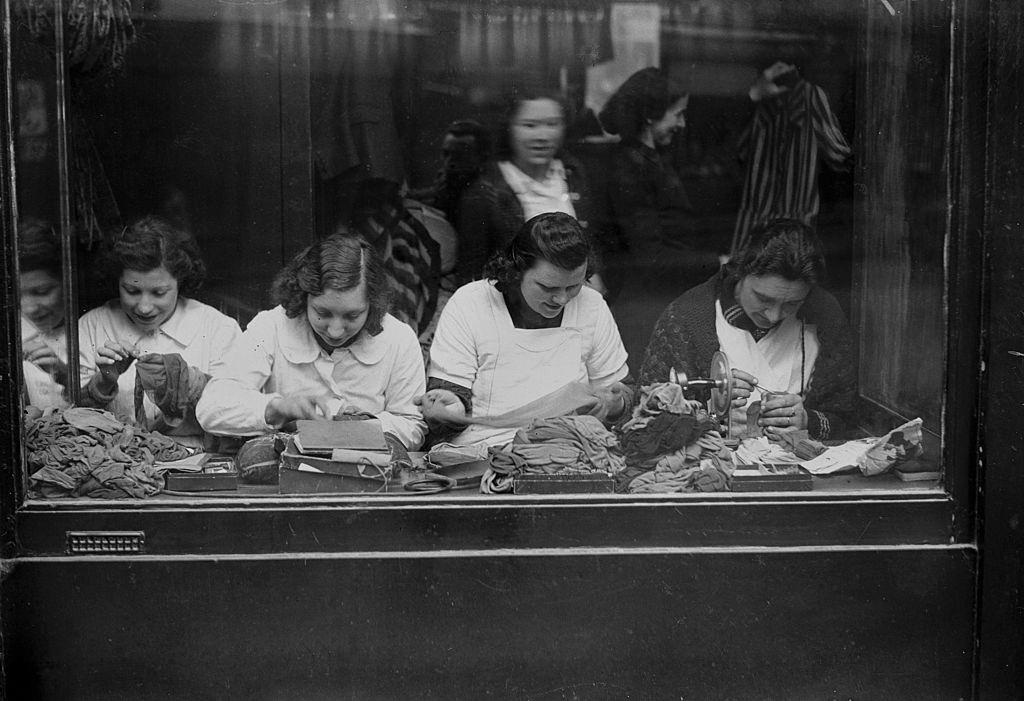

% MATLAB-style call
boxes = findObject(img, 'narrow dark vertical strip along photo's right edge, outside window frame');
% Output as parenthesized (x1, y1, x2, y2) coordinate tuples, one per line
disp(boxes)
(978, 0, 1024, 699)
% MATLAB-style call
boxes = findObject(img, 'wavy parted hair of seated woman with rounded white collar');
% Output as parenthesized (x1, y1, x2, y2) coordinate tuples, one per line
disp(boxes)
(270, 228, 391, 336)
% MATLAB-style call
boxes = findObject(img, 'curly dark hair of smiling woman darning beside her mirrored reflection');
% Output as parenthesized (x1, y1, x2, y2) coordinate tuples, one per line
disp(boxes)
(106, 216, 206, 297)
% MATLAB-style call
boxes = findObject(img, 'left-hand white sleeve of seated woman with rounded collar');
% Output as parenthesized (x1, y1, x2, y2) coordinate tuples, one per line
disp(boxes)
(196, 312, 281, 436)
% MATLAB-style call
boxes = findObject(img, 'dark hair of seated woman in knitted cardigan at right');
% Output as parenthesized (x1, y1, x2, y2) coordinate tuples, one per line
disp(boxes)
(726, 219, 825, 287)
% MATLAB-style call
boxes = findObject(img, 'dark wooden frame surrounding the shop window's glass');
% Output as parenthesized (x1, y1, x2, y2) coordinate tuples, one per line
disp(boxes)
(0, 2, 987, 558)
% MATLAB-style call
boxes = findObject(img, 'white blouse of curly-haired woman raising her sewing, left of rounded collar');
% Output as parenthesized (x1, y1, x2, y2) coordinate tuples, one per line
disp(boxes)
(78, 297, 242, 445)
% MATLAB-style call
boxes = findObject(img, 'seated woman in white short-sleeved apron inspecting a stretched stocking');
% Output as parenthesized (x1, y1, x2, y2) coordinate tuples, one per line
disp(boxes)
(420, 212, 632, 445)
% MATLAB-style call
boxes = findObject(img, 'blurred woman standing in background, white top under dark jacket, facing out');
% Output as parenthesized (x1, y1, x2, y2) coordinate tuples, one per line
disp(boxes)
(456, 90, 601, 282)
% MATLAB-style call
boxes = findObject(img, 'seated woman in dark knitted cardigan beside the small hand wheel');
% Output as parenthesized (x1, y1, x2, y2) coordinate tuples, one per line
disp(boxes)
(640, 219, 857, 440)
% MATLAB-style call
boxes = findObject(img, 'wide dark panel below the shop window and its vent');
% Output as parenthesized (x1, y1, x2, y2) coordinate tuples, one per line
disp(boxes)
(3, 547, 975, 701)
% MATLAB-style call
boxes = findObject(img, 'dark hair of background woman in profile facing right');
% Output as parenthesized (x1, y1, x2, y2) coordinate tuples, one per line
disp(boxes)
(598, 68, 687, 139)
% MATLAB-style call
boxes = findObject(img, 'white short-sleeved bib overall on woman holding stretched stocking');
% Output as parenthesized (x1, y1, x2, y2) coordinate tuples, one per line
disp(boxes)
(428, 280, 629, 445)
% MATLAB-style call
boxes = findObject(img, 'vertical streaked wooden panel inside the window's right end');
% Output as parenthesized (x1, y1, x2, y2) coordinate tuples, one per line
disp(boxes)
(855, 0, 950, 425)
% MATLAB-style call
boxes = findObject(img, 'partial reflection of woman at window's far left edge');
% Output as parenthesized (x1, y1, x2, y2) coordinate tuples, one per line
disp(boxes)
(17, 219, 68, 409)
